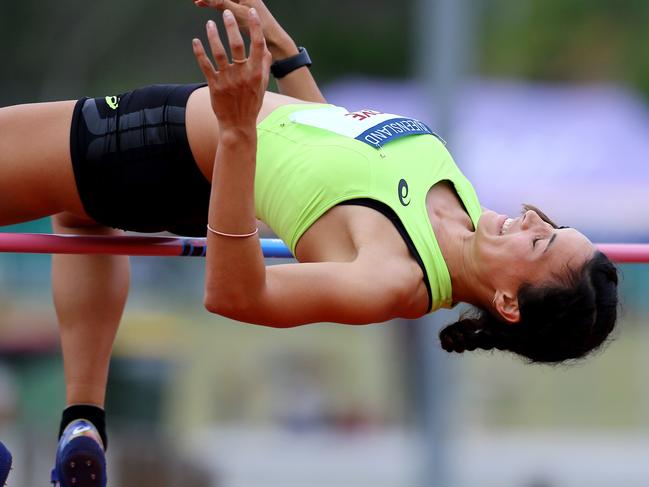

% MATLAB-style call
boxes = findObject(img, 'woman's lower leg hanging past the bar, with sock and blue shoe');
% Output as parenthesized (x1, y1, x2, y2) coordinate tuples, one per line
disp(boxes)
(52, 217, 124, 487)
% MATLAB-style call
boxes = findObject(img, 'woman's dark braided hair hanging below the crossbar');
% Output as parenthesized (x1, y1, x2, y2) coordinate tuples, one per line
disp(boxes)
(439, 252, 618, 363)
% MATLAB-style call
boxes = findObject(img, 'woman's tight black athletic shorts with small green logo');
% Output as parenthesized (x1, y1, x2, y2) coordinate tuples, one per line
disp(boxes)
(70, 84, 210, 236)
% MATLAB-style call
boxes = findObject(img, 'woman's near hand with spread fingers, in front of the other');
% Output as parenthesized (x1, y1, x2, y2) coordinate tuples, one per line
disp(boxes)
(192, 8, 271, 131)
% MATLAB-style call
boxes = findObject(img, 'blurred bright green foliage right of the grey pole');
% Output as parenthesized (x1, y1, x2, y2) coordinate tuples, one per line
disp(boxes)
(478, 0, 649, 96)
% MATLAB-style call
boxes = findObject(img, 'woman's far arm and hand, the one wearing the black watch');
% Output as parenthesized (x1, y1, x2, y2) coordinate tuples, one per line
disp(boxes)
(193, 0, 326, 103)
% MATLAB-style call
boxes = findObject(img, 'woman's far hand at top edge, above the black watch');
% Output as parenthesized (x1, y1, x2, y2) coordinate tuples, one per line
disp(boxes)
(193, 0, 298, 60)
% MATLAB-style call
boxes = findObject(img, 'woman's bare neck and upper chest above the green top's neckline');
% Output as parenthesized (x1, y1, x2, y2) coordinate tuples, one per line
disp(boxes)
(427, 192, 493, 309)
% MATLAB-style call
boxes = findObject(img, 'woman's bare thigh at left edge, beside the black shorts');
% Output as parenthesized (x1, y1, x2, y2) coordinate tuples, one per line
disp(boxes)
(0, 101, 84, 226)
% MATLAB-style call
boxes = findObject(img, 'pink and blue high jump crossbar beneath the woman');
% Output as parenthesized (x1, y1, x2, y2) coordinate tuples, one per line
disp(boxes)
(0, 233, 649, 264)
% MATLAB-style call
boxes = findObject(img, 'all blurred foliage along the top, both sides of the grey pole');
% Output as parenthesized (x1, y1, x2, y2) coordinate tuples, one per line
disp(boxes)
(0, 0, 649, 105)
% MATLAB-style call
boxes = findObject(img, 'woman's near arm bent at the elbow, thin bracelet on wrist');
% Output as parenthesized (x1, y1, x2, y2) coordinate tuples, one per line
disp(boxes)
(193, 10, 412, 327)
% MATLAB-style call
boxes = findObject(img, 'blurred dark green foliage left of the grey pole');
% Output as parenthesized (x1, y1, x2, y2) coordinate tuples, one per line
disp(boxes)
(0, 0, 410, 105)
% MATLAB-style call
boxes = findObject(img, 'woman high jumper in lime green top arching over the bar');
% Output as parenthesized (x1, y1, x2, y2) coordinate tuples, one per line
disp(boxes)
(0, 0, 617, 487)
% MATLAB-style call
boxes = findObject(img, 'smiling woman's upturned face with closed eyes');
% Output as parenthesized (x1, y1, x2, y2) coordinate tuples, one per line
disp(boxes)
(473, 205, 595, 293)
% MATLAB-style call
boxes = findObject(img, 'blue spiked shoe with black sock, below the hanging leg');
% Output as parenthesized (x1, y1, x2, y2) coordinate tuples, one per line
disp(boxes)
(52, 419, 106, 487)
